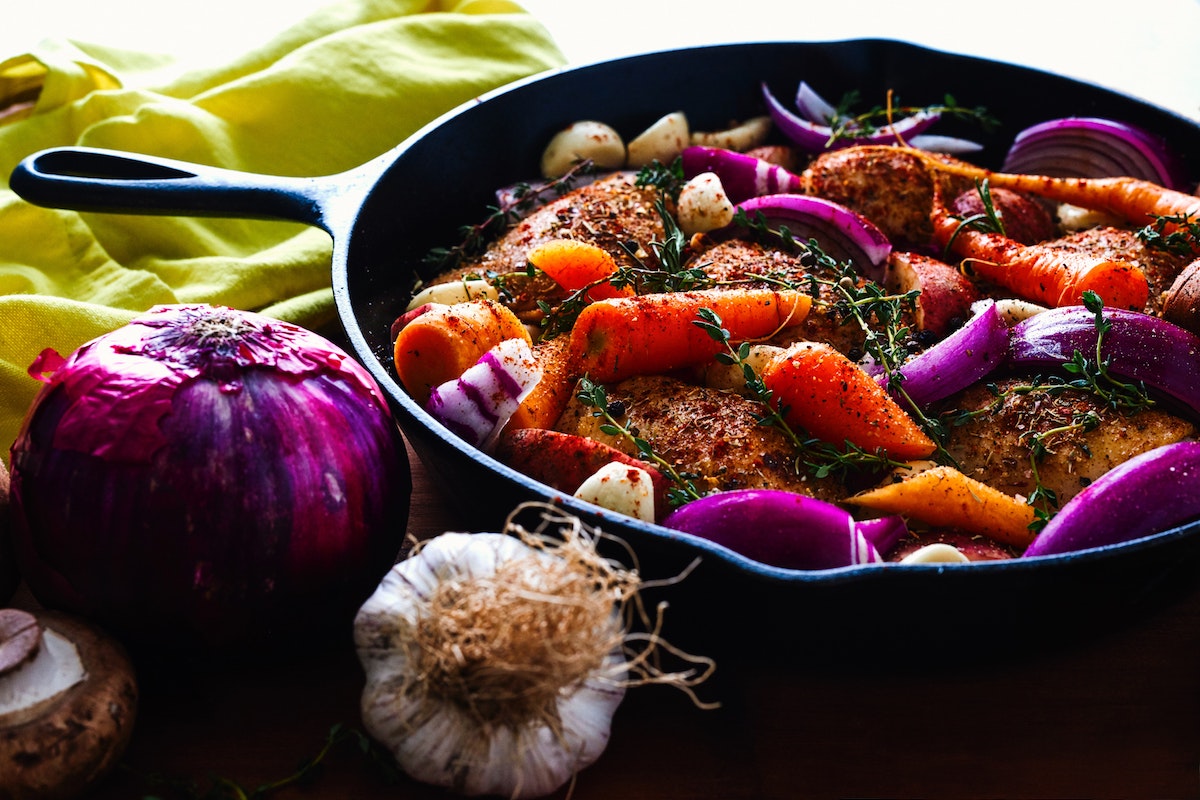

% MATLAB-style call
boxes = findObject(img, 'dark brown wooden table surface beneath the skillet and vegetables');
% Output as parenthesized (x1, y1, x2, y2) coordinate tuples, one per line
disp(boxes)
(18, 438, 1180, 800)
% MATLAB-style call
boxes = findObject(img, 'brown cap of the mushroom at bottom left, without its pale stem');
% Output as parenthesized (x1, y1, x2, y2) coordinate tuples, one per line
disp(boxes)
(0, 610, 138, 800)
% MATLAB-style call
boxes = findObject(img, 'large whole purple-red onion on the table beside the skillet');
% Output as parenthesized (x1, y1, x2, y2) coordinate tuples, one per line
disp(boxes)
(11, 306, 412, 645)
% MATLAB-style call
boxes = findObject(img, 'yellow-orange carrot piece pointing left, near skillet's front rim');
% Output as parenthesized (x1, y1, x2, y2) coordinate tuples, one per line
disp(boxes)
(847, 467, 1034, 547)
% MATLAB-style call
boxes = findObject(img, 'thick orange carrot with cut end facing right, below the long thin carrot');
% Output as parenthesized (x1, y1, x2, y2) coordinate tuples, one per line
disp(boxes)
(931, 195, 1150, 311)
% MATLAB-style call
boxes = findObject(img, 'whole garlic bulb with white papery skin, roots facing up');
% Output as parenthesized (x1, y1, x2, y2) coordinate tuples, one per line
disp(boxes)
(354, 533, 628, 798)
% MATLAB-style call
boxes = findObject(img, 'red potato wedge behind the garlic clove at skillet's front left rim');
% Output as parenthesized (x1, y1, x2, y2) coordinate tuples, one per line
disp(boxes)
(496, 428, 671, 519)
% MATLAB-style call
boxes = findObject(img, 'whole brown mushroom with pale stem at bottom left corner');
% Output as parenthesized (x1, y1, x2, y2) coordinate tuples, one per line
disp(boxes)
(0, 608, 138, 800)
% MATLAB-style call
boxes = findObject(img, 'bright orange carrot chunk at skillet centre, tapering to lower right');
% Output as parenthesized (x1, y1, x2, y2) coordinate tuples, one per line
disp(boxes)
(762, 342, 937, 459)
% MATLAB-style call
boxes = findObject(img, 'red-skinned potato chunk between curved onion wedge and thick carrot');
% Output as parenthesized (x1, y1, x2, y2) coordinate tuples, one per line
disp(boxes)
(884, 251, 980, 337)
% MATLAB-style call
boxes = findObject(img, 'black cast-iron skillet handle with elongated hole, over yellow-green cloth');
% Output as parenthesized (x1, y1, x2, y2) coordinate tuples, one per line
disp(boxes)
(10, 148, 357, 230)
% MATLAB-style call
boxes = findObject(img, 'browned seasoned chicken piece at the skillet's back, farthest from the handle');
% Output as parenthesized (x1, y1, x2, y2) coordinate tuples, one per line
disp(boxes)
(804, 148, 971, 249)
